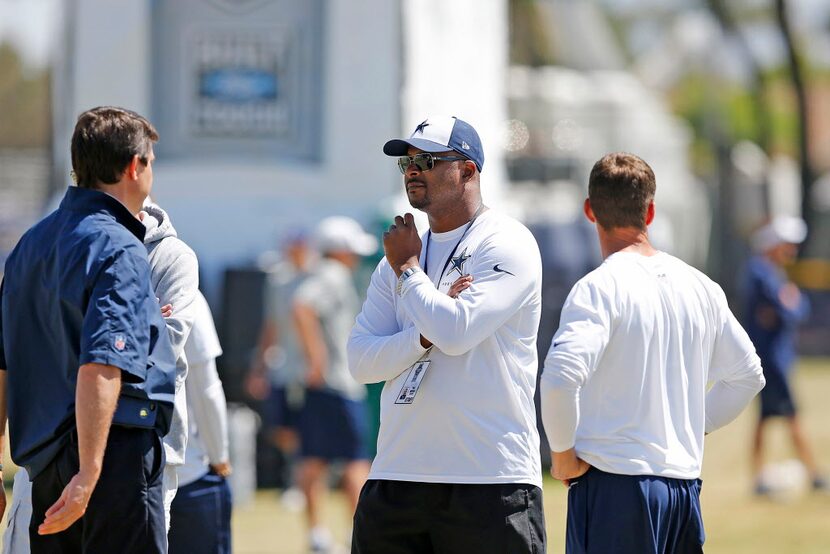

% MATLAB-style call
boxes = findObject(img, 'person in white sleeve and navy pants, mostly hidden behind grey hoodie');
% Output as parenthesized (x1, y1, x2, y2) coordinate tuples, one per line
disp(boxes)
(168, 293, 231, 554)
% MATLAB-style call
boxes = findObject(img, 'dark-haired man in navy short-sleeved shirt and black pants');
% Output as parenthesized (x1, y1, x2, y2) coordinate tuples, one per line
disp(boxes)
(0, 107, 175, 554)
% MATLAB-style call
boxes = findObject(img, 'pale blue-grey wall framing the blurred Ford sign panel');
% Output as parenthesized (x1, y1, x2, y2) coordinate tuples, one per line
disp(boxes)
(56, 0, 401, 295)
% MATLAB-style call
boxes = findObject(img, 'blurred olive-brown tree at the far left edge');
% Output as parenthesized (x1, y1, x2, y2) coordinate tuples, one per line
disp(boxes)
(0, 43, 51, 148)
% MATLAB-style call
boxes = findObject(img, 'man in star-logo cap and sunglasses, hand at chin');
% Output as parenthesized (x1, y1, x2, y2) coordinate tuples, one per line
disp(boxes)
(348, 117, 545, 554)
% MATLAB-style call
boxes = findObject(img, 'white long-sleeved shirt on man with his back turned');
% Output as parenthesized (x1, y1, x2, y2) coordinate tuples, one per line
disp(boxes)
(541, 252, 764, 479)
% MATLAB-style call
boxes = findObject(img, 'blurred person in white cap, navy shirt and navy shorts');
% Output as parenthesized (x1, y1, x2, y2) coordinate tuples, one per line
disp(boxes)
(744, 216, 830, 495)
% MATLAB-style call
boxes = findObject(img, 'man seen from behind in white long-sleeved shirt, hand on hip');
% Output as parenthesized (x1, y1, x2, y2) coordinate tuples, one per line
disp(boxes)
(541, 153, 764, 554)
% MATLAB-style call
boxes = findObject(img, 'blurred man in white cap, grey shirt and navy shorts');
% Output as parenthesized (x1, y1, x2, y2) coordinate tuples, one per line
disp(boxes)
(293, 216, 378, 552)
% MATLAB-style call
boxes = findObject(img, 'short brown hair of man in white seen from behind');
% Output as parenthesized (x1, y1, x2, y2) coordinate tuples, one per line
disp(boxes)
(588, 152, 657, 229)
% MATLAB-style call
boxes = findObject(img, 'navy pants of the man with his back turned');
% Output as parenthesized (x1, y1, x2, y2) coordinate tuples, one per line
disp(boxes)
(565, 468, 705, 554)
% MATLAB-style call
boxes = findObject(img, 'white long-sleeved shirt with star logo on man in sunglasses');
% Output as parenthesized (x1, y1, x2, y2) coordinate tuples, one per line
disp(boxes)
(348, 211, 542, 486)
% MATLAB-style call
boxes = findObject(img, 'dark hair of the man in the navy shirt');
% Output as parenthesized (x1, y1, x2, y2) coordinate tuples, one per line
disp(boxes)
(72, 106, 159, 188)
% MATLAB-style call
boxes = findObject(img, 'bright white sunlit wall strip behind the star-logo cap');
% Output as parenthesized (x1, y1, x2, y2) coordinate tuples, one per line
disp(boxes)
(401, 0, 508, 205)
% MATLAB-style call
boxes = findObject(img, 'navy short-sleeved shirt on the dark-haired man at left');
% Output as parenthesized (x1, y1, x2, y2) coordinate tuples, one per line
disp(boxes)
(0, 187, 176, 479)
